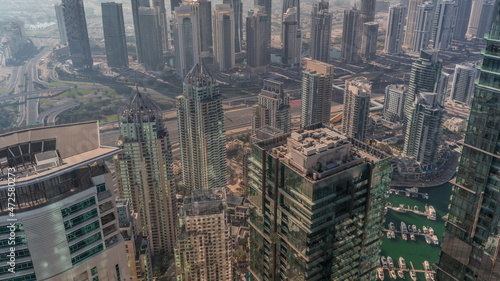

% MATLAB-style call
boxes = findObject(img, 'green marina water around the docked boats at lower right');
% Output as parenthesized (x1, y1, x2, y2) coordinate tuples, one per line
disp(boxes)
(381, 183, 452, 281)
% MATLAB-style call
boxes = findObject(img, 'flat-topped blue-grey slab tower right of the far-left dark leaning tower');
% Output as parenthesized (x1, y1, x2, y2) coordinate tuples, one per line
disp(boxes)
(101, 2, 128, 68)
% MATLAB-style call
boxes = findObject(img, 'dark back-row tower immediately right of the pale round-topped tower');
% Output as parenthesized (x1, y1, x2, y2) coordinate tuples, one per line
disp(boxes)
(246, 7, 271, 72)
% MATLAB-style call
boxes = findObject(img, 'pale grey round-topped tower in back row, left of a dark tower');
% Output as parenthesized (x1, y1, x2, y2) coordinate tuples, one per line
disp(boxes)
(212, 4, 235, 71)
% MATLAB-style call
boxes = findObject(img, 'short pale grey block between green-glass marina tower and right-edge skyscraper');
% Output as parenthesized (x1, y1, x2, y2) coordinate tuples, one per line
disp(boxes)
(450, 64, 479, 106)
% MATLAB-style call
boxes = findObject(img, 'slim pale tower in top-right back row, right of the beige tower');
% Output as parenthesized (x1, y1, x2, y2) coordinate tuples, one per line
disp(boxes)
(410, 1, 434, 52)
